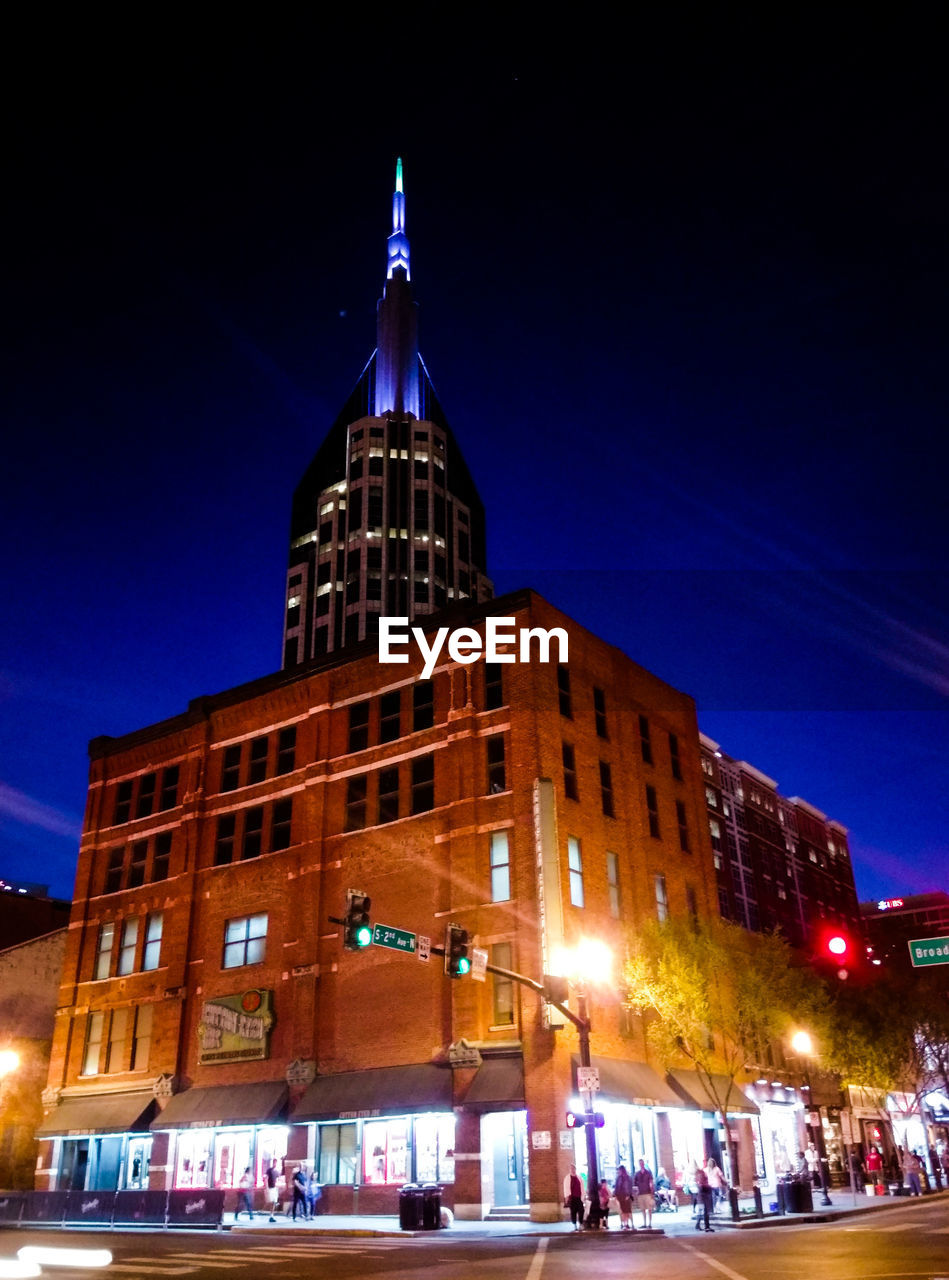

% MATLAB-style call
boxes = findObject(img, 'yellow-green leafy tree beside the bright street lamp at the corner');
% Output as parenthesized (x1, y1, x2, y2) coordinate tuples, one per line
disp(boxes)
(625, 918, 826, 1178)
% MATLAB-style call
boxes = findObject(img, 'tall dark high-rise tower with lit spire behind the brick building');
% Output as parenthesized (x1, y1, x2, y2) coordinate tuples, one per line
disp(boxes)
(283, 160, 492, 667)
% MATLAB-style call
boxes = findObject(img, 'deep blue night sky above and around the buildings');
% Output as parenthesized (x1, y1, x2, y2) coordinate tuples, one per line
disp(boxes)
(0, 9, 949, 897)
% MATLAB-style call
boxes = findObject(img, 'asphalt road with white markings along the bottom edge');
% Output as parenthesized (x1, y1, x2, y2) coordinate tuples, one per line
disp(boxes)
(0, 1201, 949, 1280)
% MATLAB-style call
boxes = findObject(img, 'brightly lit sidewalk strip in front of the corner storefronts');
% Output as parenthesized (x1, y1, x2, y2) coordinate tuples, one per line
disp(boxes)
(229, 1187, 949, 1242)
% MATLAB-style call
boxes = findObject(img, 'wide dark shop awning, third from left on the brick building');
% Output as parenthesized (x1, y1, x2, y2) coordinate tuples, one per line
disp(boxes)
(293, 1062, 452, 1121)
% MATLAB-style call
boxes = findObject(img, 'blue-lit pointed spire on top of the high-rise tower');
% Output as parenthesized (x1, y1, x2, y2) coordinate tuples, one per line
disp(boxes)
(373, 157, 421, 417)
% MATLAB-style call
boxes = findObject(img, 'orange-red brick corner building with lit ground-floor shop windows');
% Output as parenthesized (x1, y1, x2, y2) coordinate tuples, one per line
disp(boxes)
(37, 591, 754, 1219)
